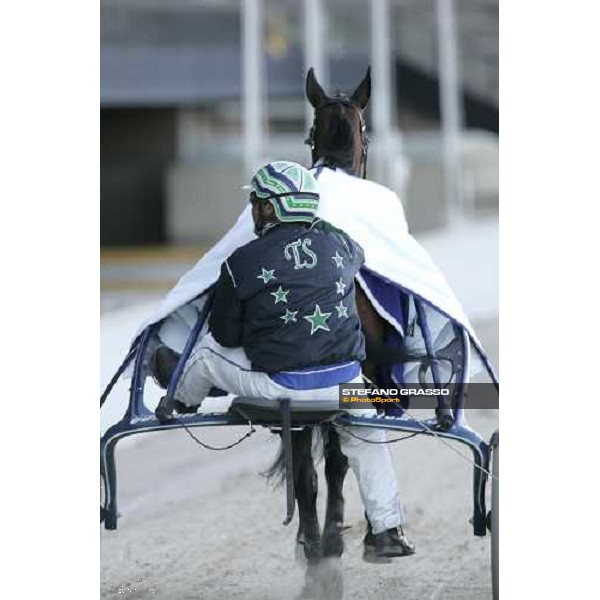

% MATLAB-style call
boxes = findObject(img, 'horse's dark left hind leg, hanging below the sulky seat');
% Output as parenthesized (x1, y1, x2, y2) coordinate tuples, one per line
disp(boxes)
(292, 427, 322, 564)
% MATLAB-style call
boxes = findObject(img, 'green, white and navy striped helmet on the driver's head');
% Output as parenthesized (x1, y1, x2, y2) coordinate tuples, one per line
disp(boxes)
(250, 160, 319, 223)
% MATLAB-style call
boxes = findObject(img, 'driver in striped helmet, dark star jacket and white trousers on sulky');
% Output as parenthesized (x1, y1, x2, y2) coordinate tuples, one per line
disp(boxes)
(154, 161, 414, 557)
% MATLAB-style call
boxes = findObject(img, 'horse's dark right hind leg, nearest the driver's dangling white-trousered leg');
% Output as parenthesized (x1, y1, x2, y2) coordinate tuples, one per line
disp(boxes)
(322, 424, 348, 556)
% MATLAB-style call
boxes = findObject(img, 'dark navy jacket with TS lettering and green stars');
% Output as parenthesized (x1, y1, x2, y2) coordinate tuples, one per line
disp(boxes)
(209, 219, 365, 373)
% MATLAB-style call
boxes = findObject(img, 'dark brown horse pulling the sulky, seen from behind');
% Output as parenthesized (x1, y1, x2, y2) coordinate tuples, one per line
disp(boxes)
(267, 68, 422, 584)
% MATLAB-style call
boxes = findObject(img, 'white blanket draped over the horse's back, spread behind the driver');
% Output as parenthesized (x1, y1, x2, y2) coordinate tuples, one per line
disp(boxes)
(138, 168, 492, 378)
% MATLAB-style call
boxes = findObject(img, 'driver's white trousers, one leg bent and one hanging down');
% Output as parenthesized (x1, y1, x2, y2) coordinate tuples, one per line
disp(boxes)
(175, 333, 404, 533)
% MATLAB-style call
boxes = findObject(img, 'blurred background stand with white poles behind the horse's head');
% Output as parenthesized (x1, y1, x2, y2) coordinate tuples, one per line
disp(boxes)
(100, 0, 499, 318)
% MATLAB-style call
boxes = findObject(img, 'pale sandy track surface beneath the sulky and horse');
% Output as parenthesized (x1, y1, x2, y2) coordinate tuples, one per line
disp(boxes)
(101, 321, 498, 600)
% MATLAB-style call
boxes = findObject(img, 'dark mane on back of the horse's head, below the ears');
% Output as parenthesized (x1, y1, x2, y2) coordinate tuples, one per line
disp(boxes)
(315, 103, 360, 171)
